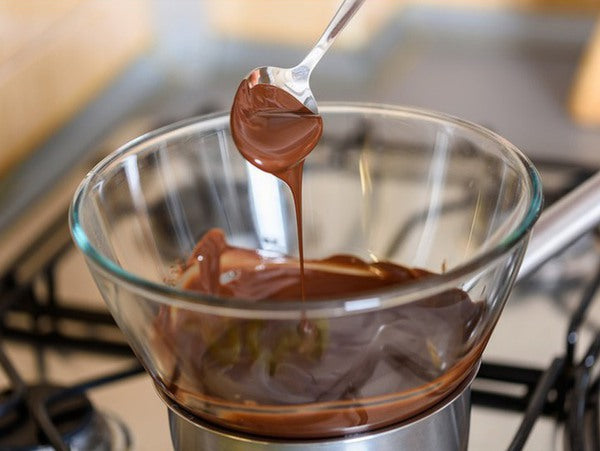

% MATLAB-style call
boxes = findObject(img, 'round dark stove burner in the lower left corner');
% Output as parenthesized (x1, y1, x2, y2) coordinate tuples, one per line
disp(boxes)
(0, 384, 122, 451)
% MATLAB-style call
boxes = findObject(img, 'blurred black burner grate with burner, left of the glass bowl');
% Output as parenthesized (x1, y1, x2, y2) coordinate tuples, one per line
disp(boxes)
(0, 212, 143, 451)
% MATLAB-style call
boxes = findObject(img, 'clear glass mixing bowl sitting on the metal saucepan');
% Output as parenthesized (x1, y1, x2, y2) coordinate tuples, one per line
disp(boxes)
(70, 104, 542, 437)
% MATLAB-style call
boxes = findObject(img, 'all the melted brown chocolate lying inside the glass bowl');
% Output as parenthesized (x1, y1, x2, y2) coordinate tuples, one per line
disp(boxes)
(151, 229, 486, 437)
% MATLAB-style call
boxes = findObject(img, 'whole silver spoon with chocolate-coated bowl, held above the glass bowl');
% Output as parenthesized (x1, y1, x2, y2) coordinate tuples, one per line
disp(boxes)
(231, 0, 364, 176)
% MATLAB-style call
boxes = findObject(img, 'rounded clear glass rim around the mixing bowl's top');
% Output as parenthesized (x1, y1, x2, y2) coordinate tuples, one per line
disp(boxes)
(69, 102, 543, 318)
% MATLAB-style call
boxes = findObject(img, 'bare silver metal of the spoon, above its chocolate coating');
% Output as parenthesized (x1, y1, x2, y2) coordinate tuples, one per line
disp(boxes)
(247, 0, 365, 114)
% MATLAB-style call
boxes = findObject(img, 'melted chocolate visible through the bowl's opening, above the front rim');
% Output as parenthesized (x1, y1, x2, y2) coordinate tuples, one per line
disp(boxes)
(184, 229, 430, 301)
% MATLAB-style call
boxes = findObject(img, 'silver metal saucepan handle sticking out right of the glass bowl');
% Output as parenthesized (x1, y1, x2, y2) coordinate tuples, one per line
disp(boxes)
(517, 172, 600, 280)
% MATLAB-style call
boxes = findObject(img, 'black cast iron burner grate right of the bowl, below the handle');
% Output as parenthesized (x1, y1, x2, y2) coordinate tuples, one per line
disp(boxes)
(471, 264, 600, 451)
